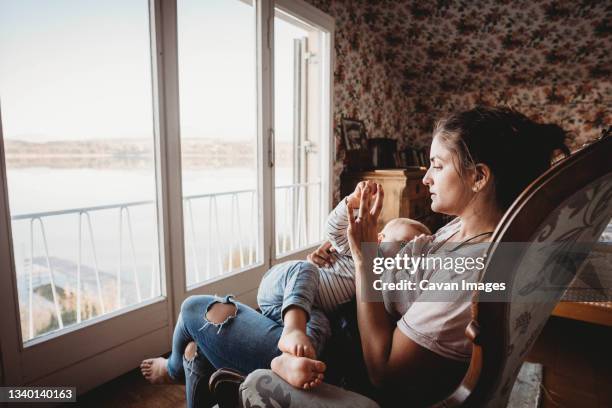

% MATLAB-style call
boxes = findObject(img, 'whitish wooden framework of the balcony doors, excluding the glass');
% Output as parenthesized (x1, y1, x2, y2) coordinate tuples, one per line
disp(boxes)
(0, 0, 335, 395)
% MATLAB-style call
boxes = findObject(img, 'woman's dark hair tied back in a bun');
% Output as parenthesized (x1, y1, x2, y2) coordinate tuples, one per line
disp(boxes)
(433, 106, 569, 210)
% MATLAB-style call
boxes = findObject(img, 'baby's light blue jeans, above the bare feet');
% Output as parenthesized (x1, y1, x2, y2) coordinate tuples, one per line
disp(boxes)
(257, 261, 331, 356)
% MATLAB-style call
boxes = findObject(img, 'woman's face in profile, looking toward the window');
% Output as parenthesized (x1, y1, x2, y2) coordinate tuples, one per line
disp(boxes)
(423, 136, 473, 215)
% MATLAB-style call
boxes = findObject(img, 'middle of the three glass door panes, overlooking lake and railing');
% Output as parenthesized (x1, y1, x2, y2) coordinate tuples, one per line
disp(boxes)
(177, 0, 267, 295)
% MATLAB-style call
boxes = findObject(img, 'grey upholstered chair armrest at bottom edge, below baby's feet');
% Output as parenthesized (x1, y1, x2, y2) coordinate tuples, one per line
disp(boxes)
(239, 370, 379, 408)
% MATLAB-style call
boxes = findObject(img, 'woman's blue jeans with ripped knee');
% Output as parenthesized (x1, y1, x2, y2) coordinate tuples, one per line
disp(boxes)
(167, 295, 283, 408)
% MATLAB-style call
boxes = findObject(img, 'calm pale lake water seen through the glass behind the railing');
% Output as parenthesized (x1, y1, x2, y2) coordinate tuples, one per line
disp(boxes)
(8, 167, 290, 273)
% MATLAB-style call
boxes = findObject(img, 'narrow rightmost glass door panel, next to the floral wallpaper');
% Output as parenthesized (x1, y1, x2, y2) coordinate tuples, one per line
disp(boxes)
(274, 8, 329, 258)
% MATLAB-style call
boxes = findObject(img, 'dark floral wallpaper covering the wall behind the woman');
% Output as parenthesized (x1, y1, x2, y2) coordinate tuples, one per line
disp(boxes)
(309, 0, 612, 200)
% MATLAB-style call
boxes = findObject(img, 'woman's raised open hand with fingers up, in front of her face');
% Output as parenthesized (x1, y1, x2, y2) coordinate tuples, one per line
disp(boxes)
(347, 181, 384, 263)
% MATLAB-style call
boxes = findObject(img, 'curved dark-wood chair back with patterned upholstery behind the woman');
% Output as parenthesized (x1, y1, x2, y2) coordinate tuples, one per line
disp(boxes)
(437, 132, 612, 407)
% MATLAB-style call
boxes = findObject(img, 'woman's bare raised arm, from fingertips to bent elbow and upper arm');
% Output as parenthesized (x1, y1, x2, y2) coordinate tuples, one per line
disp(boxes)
(348, 184, 466, 397)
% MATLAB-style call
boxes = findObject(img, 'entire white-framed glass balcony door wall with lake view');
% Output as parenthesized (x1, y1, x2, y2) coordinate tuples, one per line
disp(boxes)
(0, 0, 334, 393)
